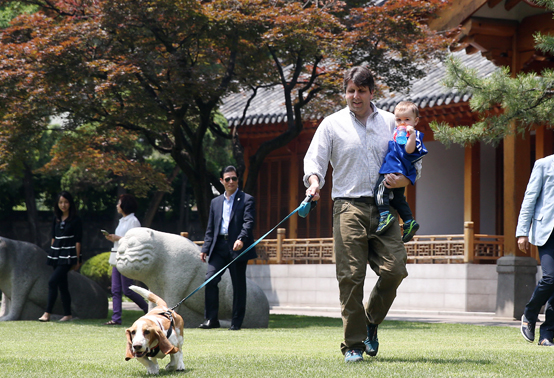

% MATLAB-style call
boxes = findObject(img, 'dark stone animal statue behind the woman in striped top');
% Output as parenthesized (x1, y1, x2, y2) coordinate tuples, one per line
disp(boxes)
(0, 237, 108, 321)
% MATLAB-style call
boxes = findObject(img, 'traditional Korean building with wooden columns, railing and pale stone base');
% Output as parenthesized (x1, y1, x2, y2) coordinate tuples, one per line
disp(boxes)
(218, 0, 554, 319)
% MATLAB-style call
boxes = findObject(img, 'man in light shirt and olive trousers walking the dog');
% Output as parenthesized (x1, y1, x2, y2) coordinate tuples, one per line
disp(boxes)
(304, 67, 421, 362)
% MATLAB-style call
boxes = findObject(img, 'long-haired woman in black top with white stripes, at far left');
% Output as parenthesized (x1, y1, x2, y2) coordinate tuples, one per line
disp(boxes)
(38, 191, 83, 322)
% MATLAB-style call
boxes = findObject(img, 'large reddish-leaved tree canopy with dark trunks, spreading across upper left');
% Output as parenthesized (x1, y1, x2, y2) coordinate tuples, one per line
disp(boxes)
(0, 0, 443, 225)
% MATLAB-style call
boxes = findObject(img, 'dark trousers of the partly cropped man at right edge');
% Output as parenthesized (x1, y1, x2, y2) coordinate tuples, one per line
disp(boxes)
(524, 232, 554, 341)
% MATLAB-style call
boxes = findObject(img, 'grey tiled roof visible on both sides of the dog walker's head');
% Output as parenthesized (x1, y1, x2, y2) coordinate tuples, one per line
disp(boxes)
(220, 50, 497, 125)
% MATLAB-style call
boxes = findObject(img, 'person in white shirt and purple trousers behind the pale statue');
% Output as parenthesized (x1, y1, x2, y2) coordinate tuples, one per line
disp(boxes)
(104, 194, 148, 325)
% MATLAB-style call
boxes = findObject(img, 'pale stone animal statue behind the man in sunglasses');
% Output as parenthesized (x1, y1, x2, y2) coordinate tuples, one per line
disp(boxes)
(116, 227, 269, 328)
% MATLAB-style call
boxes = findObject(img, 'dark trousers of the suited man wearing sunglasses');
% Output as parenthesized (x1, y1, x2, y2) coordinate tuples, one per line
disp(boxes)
(204, 236, 248, 328)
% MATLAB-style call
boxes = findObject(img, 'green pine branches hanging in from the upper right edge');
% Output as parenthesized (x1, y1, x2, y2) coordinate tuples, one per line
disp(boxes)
(430, 0, 554, 145)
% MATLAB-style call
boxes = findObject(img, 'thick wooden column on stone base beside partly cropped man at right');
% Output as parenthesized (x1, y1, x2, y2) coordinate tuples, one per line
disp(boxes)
(504, 132, 531, 256)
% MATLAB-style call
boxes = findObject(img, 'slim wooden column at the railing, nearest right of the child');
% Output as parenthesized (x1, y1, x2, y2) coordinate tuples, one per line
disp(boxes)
(464, 143, 481, 234)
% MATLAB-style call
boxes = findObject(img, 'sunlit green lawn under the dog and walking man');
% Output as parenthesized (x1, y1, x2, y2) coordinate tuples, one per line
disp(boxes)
(0, 311, 554, 378)
